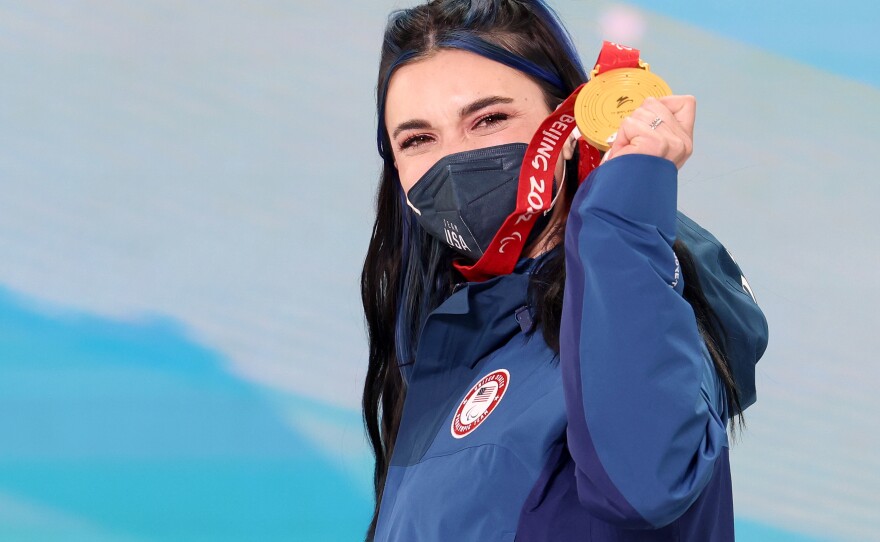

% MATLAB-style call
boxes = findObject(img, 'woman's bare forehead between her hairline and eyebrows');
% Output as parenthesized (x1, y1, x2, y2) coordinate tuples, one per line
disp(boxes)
(385, 49, 543, 125)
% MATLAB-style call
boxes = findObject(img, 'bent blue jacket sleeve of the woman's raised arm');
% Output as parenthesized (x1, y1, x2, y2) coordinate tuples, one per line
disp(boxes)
(560, 155, 728, 528)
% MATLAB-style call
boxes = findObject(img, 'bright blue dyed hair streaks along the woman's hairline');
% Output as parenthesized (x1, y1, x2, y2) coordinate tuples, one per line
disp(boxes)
(376, 31, 565, 161)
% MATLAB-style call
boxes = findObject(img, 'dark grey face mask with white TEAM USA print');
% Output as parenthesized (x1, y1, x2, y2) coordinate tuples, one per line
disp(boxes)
(407, 143, 555, 260)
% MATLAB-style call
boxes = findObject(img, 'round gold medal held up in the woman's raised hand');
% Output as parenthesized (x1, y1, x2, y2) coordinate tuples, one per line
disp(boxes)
(574, 65, 672, 151)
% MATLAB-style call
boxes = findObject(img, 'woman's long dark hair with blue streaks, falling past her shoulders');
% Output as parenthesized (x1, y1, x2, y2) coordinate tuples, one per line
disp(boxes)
(361, 0, 740, 540)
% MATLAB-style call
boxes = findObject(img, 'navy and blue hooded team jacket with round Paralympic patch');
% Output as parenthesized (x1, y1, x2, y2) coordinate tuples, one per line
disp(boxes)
(375, 155, 767, 542)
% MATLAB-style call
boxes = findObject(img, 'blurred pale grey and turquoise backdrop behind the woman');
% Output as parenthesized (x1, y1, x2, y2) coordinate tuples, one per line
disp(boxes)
(0, 0, 880, 542)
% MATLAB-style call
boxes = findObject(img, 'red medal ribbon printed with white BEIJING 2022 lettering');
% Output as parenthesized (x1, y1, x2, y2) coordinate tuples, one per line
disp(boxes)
(453, 41, 639, 282)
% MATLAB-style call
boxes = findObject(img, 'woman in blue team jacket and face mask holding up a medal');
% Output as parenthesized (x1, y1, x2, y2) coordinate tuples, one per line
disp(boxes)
(362, 0, 766, 541)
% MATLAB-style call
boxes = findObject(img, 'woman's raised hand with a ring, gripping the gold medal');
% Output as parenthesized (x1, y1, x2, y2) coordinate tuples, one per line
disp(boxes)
(603, 96, 697, 169)
